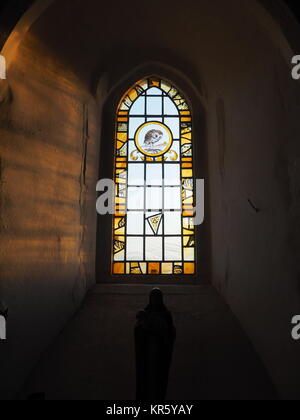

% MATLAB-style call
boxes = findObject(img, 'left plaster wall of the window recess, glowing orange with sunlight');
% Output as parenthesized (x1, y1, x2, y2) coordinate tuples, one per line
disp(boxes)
(0, 32, 99, 398)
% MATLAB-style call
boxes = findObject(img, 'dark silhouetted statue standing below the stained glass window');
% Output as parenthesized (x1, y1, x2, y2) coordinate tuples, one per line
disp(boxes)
(135, 289, 176, 402)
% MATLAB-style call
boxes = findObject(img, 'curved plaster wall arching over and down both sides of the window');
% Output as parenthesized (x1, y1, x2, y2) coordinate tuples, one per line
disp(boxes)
(0, 0, 300, 398)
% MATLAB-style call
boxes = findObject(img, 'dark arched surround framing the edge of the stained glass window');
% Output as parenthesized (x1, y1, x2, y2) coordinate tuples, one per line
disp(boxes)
(96, 62, 210, 284)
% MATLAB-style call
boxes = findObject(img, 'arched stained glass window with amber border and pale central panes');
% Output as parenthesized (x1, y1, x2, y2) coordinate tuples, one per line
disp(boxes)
(112, 77, 196, 275)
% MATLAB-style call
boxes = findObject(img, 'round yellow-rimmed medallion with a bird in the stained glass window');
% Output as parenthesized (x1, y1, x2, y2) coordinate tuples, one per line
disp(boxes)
(135, 122, 173, 157)
